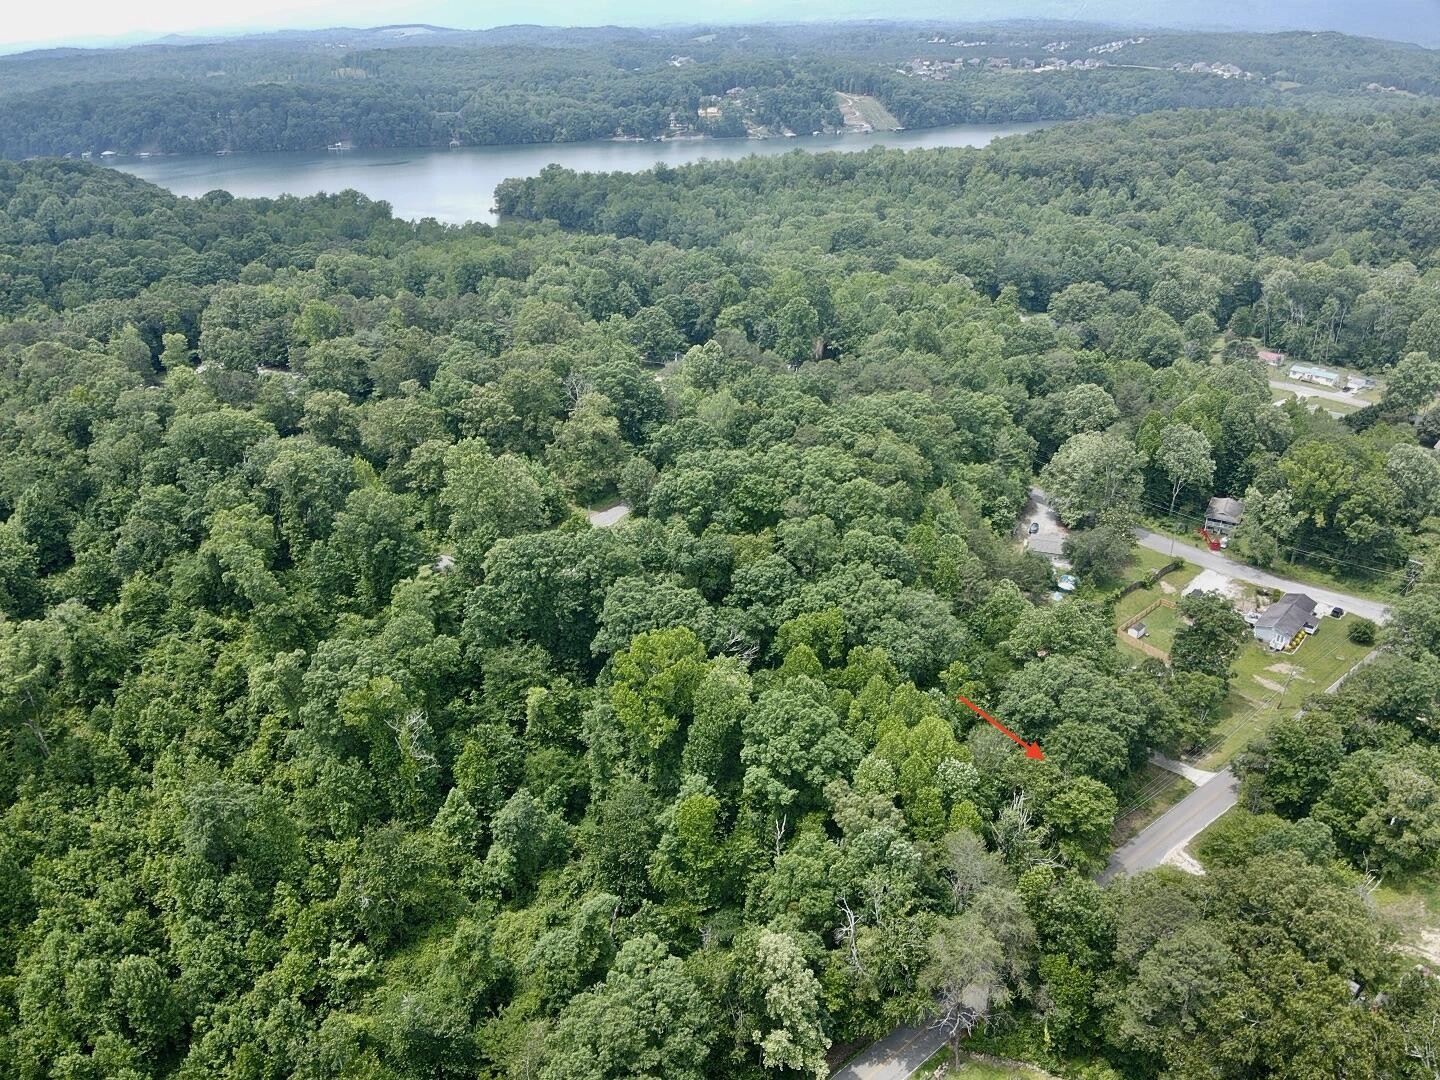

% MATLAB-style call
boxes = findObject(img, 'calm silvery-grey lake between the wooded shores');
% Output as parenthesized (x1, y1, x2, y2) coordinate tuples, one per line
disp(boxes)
(107, 124, 1045, 223)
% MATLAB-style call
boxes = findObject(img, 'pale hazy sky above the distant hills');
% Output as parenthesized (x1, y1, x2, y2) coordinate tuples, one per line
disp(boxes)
(8, 0, 1440, 52)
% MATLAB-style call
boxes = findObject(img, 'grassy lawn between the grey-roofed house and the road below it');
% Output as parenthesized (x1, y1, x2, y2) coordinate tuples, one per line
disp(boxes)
(1200, 615, 1371, 769)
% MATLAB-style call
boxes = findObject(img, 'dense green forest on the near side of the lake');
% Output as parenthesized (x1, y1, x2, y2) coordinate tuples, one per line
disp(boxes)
(0, 112, 1440, 1080)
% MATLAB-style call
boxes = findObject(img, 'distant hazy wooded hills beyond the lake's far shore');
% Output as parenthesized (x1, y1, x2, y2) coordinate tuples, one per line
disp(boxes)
(0, 23, 1440, 158)
